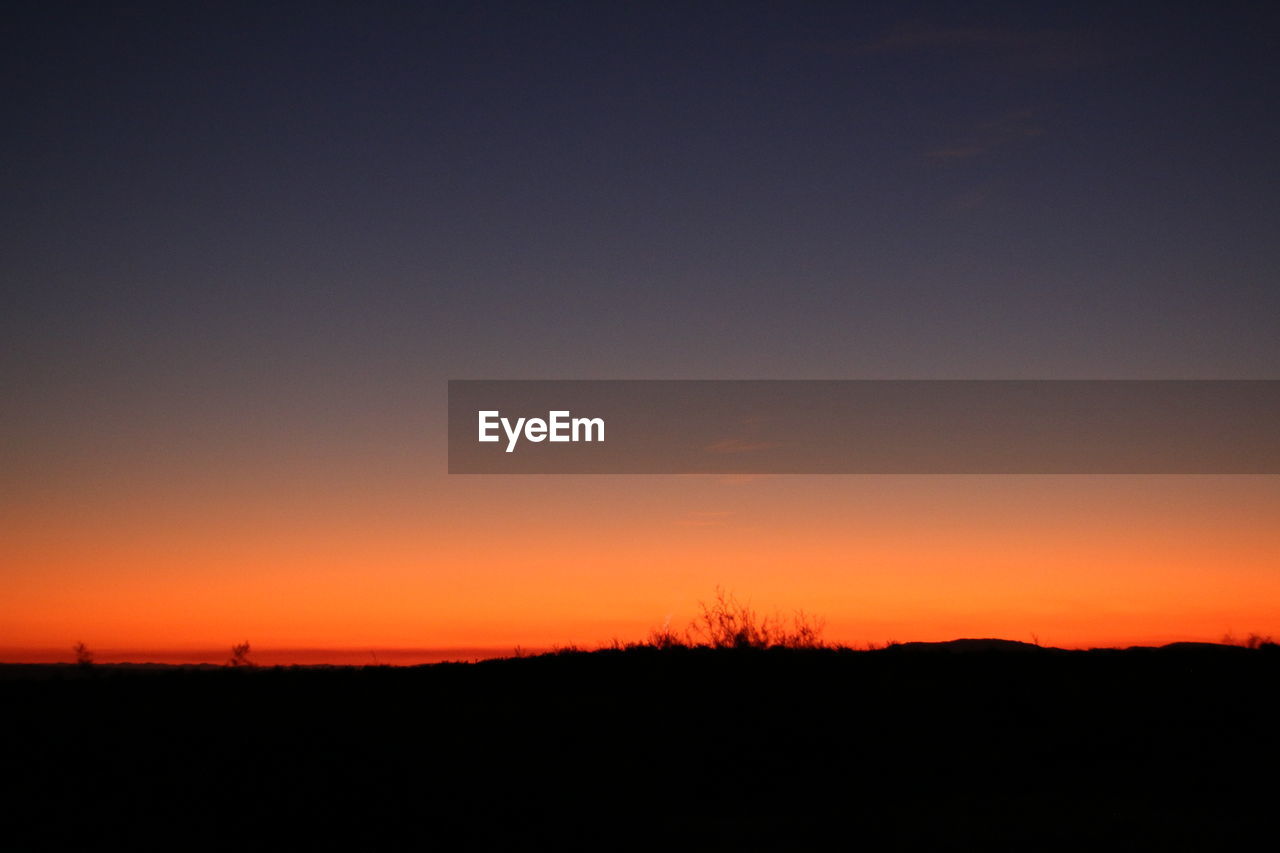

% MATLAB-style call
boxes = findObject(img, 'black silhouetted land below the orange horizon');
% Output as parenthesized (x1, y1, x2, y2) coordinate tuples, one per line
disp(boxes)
(0, 640, 1280, 850)
